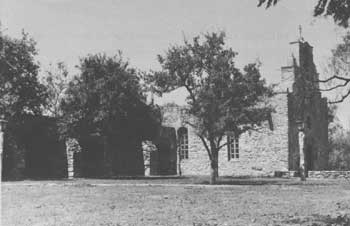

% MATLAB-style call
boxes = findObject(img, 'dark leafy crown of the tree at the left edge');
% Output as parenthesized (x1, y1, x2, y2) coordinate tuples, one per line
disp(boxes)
(0, 32, 47, 119)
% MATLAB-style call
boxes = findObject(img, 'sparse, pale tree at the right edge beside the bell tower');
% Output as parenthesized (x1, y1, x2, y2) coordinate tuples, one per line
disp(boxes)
(318, 32, 350, 103)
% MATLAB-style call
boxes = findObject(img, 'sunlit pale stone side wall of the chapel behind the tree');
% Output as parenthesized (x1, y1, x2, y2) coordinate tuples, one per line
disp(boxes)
(163, 94, 288, 176)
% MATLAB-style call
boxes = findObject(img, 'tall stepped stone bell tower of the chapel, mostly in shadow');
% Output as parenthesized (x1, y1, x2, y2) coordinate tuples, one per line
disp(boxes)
(280, 35, 329, 171)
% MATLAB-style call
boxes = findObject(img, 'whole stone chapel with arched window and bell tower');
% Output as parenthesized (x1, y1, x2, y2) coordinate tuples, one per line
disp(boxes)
(146, 39, 329, 176)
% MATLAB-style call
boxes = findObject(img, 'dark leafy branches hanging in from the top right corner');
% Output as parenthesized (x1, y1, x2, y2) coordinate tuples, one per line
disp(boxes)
(258, 0, 350, 28)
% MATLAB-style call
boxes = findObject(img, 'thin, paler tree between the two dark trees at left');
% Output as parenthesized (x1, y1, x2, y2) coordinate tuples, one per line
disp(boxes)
(41, 62, 69, 118)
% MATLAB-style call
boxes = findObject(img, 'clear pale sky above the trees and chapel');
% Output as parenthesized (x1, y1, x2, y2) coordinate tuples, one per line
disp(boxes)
(0, 0, 350, 127)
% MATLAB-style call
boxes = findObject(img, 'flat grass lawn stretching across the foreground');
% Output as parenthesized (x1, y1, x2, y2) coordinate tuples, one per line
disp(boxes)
(2, 178, 350, 226)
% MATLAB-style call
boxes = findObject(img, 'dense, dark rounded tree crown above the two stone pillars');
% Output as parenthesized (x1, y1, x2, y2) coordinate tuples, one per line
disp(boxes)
(61, 54, 159, 139)
